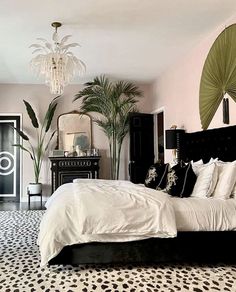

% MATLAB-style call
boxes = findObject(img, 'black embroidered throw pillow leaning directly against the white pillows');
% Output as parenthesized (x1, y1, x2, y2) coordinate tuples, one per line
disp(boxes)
(165, 163, 197, 198)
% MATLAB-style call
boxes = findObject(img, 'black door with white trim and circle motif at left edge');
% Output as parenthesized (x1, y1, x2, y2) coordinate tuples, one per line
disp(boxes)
(0, 114, 20, 201)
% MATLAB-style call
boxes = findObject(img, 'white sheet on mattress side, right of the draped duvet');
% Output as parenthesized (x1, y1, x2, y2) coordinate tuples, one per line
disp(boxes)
(171, 197, 236, 231)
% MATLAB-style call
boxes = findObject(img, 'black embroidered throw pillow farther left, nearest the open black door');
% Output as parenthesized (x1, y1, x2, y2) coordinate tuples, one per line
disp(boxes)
(144, 162, 169, 189)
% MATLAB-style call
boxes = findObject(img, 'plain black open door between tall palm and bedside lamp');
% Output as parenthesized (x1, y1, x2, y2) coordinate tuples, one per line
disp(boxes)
(129, 113, 154, 183)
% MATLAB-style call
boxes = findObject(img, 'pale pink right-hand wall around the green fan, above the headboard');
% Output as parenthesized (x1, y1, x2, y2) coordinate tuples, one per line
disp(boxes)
(152, 22, 236, 161)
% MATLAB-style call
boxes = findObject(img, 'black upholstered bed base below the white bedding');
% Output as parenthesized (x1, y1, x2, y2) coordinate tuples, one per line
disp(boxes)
(49, 231, 236, 265)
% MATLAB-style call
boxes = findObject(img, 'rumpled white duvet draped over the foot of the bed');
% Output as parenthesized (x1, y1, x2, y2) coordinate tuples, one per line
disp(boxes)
(38, 179, 177, 266)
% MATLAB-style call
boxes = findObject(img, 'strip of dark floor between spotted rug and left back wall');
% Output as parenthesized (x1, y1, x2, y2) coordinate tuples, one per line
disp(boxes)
(0, 201, 46, 211)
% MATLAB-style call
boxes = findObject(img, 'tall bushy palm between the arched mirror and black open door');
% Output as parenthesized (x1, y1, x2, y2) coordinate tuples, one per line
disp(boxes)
(74, 76, 142, 179)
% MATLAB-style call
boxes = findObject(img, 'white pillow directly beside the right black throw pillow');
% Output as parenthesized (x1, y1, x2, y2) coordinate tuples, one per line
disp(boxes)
(191, 163, 218, 198)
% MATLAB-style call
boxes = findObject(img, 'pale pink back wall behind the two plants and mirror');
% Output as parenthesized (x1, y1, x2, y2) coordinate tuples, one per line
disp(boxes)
(0, 84, 151, 201)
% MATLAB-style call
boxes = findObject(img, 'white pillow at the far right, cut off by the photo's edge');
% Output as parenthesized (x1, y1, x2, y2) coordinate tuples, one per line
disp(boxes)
(213, 161, 236, 200)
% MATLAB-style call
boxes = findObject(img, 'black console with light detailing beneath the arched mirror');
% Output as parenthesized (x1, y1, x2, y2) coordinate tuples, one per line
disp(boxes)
(49, 156, 100, 193)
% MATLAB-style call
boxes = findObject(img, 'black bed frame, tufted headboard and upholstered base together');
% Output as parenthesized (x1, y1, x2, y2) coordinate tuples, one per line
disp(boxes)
(49, 126, 236, 264)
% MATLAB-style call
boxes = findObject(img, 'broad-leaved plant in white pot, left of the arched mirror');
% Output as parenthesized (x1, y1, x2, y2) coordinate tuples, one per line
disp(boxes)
(13, 97, 58, 194)
